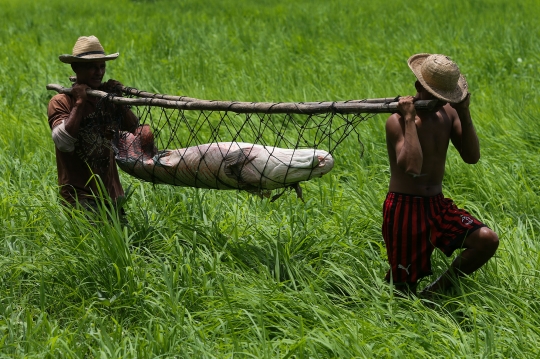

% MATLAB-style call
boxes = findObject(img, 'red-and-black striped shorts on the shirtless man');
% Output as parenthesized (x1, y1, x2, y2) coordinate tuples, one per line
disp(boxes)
(382, 192, 486, 284)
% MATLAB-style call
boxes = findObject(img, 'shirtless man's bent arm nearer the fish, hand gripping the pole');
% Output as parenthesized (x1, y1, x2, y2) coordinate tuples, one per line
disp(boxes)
(386, 96, 424, 177)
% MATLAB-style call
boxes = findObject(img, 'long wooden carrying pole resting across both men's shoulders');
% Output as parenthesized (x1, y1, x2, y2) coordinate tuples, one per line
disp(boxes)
(47, 84, 439, 115)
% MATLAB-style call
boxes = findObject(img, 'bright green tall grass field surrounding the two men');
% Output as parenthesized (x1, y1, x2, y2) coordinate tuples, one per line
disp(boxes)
(0, 0, 540, 358)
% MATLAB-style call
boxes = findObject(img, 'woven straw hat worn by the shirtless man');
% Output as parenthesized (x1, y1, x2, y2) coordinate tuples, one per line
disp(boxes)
(407, 54, 468, 103)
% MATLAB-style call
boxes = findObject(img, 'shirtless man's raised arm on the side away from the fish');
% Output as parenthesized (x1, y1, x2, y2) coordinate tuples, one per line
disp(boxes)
(450, 94, 480, 164)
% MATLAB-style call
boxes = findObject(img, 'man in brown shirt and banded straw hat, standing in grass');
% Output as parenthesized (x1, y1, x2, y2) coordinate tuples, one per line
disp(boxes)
(47, 36, 138, 217)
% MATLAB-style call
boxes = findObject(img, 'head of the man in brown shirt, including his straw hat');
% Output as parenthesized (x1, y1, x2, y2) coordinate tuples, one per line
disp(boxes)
(59, 35, 118, 89)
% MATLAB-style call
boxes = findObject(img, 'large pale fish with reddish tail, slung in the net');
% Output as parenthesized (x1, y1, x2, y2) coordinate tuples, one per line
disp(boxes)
(116, 125, 334, 197)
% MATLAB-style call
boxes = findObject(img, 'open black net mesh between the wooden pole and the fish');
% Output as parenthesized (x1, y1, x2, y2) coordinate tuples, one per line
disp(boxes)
(128, 106, 374, 154)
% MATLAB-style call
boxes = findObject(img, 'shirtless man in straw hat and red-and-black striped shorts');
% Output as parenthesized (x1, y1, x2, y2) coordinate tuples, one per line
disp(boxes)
(382, 54, 499, 297)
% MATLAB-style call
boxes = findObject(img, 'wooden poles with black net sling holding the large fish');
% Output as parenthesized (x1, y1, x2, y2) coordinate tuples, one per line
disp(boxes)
(47, 85, 434, 198)
